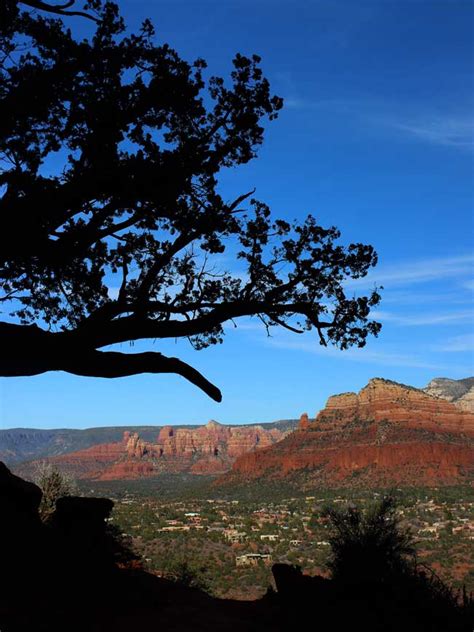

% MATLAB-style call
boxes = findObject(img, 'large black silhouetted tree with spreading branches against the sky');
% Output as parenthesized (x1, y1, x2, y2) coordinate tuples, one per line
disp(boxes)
(0, 0, 380, 401)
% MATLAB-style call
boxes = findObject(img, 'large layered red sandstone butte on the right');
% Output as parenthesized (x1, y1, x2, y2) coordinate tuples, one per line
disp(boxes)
(217, 378, 474, 487)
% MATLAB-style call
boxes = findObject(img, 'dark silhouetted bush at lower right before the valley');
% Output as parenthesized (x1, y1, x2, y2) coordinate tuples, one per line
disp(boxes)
(315, 497, 473, 632)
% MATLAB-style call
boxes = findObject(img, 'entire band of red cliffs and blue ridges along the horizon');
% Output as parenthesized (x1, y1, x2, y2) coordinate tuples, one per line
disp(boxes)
(0, 377, 474, 485)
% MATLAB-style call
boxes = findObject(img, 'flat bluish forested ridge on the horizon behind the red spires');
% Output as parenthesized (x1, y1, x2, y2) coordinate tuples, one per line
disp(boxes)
(0, 419, 298, 465)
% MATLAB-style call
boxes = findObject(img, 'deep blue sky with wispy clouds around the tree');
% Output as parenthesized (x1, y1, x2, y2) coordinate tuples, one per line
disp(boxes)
(0, 0, 474, 428)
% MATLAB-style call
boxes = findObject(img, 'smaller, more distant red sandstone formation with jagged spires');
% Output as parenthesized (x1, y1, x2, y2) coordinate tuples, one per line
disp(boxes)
(36, 421, 288, 480)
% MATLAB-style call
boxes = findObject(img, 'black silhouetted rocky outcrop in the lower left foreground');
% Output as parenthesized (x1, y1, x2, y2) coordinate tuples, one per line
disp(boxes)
(0, 462, 125, 632)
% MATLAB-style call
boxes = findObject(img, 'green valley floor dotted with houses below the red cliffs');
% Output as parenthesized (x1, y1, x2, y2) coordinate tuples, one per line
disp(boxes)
(78, 475, 474, 599)
